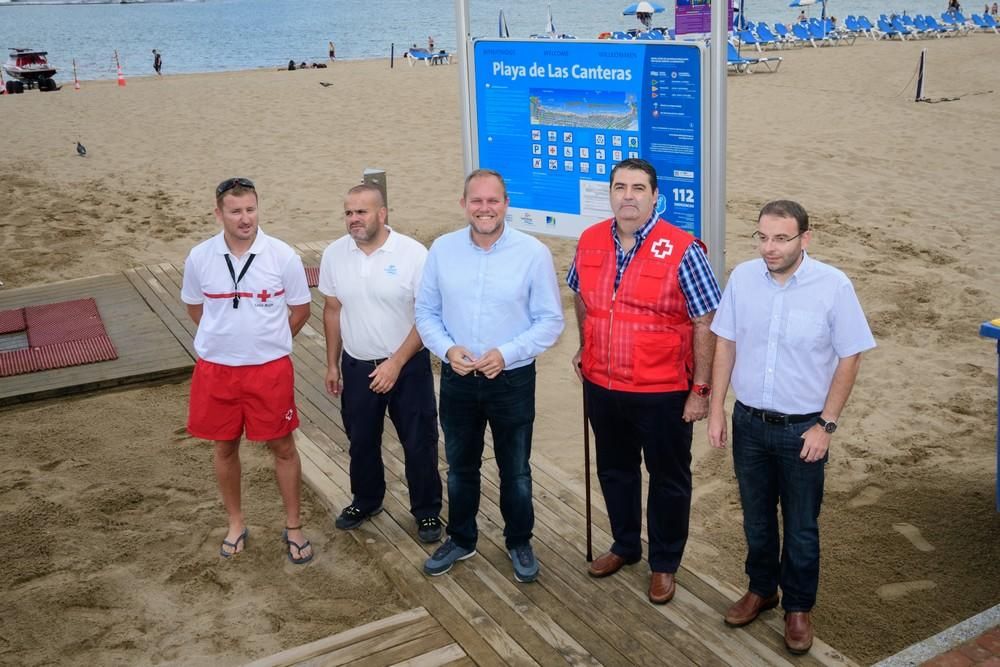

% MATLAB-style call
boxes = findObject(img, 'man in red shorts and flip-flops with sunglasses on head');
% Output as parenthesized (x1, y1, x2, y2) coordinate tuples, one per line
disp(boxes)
(181, 178, 313, 564)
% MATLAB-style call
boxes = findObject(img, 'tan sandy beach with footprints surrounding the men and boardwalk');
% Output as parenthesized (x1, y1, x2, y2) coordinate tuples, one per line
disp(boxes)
(0, 34, 1000, 665)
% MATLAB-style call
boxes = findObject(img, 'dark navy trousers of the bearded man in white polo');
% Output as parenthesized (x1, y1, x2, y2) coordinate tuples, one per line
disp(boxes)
(340, 350, 441, 520)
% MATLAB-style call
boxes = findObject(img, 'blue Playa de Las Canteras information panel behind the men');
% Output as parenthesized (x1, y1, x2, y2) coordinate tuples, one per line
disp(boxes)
(471, 39, 707, 237)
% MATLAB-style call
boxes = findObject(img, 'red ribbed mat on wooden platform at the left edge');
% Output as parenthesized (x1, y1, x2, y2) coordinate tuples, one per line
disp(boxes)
(0, 299, 118, 377)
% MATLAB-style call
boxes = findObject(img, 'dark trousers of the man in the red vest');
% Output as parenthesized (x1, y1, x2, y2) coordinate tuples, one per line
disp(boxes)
(583, 381, 693, 572)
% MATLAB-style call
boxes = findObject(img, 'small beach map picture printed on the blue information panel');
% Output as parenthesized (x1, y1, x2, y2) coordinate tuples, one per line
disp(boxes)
(528, 88, 639, 131)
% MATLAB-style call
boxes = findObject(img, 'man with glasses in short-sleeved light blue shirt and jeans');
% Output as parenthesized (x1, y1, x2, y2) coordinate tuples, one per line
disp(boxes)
(708, 201, 875, 654)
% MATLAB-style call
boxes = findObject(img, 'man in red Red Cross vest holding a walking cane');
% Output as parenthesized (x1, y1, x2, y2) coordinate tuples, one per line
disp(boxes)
(566, 159, 720, 604)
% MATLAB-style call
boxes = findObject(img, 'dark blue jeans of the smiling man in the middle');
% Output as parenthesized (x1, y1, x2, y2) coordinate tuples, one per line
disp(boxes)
(441, 364, 535, 549)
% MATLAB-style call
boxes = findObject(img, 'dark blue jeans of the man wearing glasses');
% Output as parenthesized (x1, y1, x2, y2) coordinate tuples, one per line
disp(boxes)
(733, 404, 829, 611)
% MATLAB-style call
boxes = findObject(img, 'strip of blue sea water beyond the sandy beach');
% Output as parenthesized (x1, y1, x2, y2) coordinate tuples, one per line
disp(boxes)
(0, 0, 960, 82)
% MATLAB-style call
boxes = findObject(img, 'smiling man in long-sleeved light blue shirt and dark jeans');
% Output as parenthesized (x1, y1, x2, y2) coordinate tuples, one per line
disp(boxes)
(416, 169, 564, 583)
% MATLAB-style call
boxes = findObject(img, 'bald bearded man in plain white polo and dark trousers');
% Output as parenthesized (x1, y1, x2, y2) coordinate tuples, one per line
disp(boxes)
(319, 184, 441, 543)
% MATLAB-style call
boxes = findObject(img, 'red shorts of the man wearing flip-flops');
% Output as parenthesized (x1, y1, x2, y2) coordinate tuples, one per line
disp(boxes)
(188, 357, 299, 441)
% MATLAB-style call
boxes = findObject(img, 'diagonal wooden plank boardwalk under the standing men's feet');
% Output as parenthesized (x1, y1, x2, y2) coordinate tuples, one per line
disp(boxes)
(3, 252, 854, 667)
